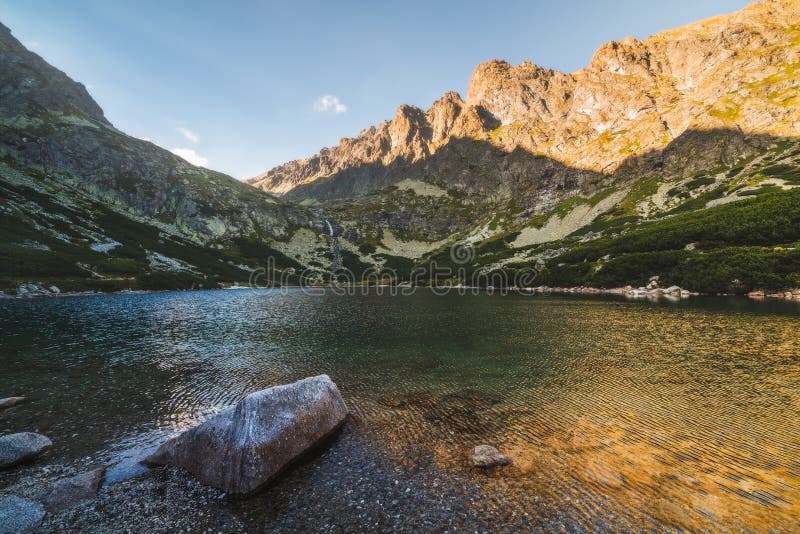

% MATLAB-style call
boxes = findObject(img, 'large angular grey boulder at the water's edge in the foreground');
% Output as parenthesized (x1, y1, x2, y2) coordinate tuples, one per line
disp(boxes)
(143, 375, 347, 494)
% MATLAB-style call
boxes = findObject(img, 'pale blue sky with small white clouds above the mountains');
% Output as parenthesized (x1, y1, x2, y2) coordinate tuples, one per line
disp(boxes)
(0, 0, 748, 178)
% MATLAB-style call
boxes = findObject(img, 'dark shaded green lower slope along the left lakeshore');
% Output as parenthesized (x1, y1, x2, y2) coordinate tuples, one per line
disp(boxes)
(0, 163, 302, 292)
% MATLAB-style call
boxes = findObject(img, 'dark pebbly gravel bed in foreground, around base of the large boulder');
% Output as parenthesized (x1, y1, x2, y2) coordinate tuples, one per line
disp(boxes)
(0, 421, 544, 532)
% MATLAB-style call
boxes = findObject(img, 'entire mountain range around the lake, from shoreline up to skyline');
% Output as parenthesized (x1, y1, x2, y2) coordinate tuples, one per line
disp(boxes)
(0, 4, 800, 298)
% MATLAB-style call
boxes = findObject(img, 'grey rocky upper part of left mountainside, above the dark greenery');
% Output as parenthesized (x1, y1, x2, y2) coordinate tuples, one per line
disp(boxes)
(0, 20, 310, 242)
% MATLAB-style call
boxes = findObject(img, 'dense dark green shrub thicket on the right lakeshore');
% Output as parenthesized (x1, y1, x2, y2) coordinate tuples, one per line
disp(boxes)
(532, 189, 800, 292)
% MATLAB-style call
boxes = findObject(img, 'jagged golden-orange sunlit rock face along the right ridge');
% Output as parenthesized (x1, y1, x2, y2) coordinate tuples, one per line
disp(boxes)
(249, 0, 800, 198)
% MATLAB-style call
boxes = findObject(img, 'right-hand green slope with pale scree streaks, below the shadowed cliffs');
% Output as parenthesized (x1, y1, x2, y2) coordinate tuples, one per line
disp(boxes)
(400, 141, 800, 292)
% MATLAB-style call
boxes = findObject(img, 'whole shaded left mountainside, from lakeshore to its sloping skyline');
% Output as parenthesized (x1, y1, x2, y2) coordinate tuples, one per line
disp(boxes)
(0, 25, 321, 289)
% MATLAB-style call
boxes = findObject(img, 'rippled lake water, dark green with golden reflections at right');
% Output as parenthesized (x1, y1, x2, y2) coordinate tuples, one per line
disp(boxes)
(0, 290, 800, 531)
